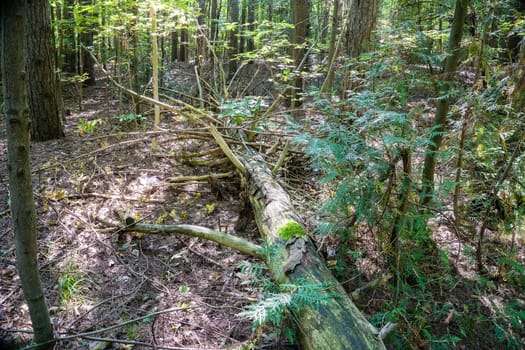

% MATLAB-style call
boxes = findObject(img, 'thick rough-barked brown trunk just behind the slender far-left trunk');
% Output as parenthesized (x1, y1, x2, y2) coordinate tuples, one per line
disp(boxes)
(26, 0, 64, 141)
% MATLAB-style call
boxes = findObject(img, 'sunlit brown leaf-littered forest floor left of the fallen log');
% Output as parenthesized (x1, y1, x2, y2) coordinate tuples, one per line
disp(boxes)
(0, 70, 304, 349)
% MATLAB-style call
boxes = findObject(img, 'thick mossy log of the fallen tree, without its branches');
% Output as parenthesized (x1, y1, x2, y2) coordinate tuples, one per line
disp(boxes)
(241, 150, 385, 350)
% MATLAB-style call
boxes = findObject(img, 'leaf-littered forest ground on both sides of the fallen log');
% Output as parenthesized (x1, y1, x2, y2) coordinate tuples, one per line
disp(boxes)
(0, 61, 525, 349)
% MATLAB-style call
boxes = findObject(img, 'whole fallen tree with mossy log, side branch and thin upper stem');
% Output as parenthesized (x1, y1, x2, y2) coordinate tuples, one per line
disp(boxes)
(87, 47, 385, 350)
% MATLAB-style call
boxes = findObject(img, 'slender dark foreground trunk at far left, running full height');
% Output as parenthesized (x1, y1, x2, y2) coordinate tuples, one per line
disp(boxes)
(0, 0, 53, 349)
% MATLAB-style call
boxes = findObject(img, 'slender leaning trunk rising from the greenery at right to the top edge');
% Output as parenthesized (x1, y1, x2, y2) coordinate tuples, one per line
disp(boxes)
(421, 0, 469, 206)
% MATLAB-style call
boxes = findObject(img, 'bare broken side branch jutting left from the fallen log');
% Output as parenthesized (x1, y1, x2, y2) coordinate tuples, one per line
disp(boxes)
(124, 217, 265, 258)
